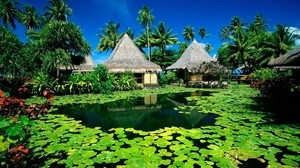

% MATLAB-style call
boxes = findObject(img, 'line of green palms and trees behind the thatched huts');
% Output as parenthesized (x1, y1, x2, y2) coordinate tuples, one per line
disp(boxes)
(0, 0, 299, 77)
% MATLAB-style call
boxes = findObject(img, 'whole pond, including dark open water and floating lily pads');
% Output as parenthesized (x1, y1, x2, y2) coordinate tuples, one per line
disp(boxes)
(28, 85, 300, 168)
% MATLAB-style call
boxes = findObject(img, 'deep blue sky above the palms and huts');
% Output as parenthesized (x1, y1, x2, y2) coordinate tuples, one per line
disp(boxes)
(15, 0, 300, 64)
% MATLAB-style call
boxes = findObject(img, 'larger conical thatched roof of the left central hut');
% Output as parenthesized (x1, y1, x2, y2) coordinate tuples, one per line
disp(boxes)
(103, 33, 162, 73)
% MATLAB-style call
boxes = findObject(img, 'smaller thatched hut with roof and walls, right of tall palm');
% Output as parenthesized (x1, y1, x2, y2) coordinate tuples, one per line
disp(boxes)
(166, 40, 213, 81)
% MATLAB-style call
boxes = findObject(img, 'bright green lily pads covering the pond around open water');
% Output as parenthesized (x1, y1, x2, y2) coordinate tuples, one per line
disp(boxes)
(30, 85, 300, 167)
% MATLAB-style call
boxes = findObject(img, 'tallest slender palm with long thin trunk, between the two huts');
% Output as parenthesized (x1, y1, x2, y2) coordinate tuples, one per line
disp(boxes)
(137, 6, 154, 61)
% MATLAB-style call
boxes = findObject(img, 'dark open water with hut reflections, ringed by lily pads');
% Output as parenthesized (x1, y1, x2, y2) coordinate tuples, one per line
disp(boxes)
(56, 91, 217, 131)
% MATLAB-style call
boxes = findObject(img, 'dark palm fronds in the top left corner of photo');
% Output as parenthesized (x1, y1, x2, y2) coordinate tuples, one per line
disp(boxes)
(0, 0, 20, 29)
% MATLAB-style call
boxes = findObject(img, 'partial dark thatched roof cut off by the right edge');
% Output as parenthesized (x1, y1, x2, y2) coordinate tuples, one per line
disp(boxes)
(268, 48, 300, 69)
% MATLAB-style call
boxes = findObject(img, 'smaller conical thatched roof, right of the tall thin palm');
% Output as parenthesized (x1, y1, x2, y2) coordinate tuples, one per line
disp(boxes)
(166, 40, 213, 71)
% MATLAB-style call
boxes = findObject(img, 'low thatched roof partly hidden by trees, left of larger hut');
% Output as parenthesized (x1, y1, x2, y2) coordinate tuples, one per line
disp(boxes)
(59, 55, 96, 72)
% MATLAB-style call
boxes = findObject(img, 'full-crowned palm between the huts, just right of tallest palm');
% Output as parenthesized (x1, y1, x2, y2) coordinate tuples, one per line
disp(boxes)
(153, 22, 178, 68)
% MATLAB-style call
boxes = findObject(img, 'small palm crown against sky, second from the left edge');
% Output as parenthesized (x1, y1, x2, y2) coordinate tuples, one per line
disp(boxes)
(21, 4, 39, 29)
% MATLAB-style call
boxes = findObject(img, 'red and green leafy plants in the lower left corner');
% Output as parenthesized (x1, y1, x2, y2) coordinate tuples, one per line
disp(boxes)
(0, 88, 54, 167)
